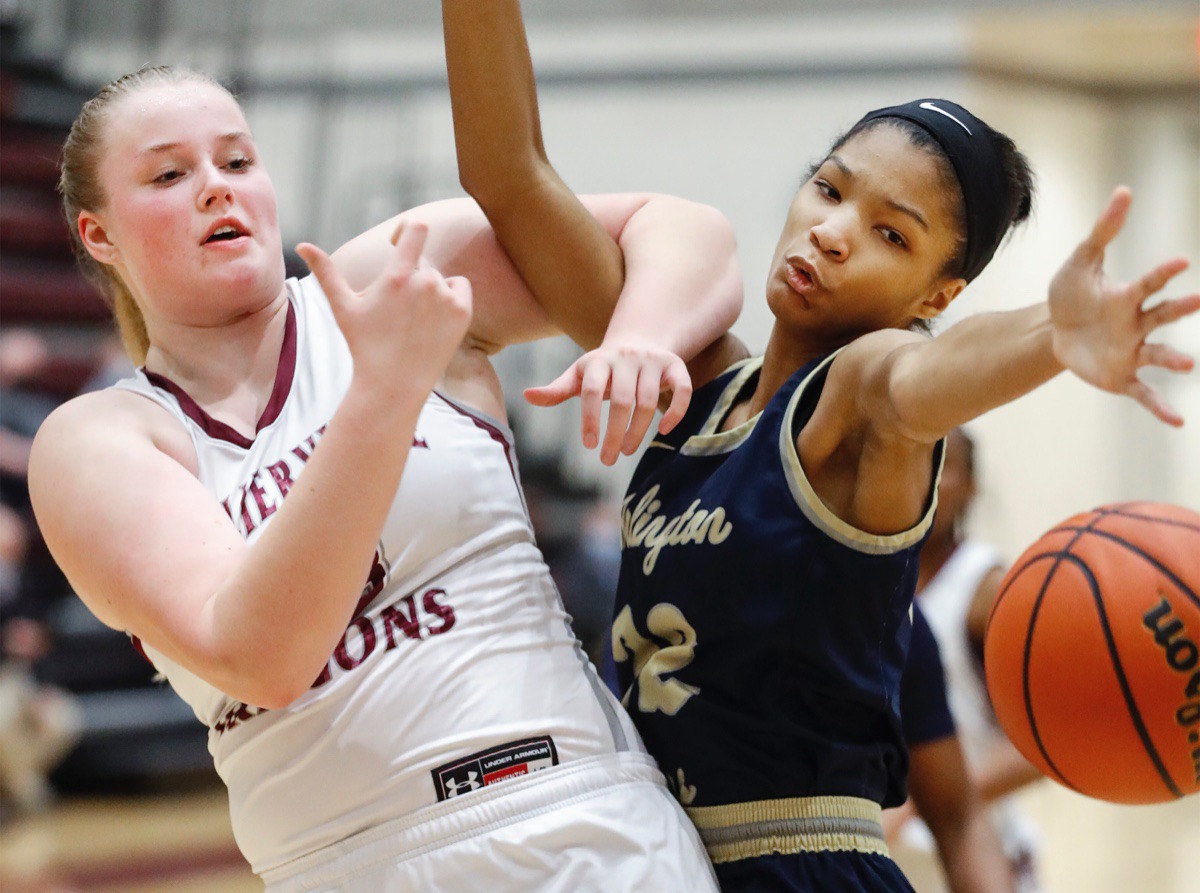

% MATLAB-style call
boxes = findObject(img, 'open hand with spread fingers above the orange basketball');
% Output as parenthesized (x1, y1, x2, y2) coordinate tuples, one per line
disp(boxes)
(1050, 186, 1200, 426)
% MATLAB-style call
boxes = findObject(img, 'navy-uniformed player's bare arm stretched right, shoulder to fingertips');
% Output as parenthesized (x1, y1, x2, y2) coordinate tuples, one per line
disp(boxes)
(798, 188, 1200, 533)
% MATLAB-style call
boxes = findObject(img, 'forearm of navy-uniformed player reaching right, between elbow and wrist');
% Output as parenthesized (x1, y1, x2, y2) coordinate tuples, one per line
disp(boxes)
(886, 304, 1063, 443)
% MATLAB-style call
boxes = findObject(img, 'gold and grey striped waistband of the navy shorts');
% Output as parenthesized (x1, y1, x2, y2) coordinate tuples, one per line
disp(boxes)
(686, 797, 890, 864)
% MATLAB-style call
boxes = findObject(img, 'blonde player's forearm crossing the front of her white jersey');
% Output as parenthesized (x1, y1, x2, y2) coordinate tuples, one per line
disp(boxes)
(202, 383, 426, 707)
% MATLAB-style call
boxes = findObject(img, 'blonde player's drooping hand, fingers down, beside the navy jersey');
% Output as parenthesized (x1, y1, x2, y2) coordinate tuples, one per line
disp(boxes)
(524, 344, 691, 465)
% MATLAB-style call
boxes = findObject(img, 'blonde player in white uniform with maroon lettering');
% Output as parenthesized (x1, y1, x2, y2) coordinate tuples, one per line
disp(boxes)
(30, 68, 740, 892)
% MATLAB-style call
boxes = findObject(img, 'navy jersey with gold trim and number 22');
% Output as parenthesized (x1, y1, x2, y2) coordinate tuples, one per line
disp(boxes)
(612, 355, 942, 811)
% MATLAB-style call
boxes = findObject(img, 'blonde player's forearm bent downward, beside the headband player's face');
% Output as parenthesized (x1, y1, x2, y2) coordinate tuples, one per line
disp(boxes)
(605, 196, 743, 360)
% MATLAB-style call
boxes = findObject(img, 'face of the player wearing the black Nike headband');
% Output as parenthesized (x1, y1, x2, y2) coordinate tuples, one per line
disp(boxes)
(767, 126, 962, 343)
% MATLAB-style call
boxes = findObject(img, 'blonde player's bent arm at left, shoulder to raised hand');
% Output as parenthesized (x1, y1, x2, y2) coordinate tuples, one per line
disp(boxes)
(29, 227, 470, 708)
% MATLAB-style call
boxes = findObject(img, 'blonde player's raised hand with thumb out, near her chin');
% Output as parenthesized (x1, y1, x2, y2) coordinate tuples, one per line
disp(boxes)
(296, 222, 472, 391)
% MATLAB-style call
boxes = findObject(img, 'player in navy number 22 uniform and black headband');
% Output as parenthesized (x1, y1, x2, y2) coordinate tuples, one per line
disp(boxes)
(443, 0, 1200, 892)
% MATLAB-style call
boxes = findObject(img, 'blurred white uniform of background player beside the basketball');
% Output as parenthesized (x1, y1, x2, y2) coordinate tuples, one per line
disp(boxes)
(917, 540, 1032, 856)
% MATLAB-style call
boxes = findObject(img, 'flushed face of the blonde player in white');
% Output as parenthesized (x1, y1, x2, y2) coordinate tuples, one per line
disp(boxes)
(85, 82, 283, 325)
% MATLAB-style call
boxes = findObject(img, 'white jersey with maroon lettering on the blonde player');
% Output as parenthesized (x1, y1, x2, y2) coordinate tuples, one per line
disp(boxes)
(116, 277, 641, 871)
